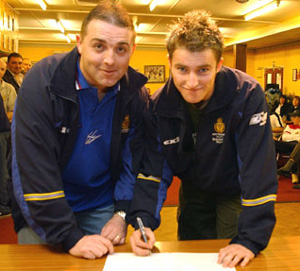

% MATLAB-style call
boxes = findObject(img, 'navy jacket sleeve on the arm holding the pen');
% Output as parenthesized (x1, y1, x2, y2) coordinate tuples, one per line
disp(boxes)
(128, 100, 173, 230)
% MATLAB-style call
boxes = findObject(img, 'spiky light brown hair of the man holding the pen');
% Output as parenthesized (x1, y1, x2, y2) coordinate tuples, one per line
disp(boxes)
(167, 10, 224, 61)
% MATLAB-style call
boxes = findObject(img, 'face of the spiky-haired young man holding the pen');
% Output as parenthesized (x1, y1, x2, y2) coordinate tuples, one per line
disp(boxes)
(169, 48, 223, 104)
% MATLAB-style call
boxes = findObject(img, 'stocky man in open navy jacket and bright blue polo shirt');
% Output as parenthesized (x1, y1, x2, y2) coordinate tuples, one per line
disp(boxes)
(12, 1, 148, 259)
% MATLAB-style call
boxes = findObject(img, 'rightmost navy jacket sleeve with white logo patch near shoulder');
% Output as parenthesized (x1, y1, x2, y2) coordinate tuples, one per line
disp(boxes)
(231, 84, 277, 254)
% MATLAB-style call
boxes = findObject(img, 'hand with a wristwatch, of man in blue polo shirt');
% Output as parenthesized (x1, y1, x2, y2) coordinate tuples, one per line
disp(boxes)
(101, 214, 127, 245)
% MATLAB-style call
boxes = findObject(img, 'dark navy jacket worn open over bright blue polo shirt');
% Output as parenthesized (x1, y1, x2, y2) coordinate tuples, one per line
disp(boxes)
(12, 48, 148, 253)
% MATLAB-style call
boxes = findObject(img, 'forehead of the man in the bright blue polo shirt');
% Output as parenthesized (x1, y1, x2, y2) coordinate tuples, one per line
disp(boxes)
(84, 19, 133, 42)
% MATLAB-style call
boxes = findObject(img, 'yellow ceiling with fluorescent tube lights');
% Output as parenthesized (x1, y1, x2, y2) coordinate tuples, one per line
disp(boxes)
(6, 0, 300, 49)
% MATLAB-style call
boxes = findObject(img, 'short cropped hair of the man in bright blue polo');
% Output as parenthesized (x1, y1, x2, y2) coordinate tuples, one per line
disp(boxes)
(80, 0, 136, 42)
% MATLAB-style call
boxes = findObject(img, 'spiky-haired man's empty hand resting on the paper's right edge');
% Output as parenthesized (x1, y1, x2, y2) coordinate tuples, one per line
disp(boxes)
(218, 244, 255, 267)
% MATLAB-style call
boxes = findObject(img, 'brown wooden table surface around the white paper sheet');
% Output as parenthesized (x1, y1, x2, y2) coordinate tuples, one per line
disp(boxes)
(0, 236, 300, 271)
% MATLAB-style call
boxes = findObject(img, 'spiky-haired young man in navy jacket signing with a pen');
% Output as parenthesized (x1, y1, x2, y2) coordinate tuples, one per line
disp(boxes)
(130, 11, 277, 267)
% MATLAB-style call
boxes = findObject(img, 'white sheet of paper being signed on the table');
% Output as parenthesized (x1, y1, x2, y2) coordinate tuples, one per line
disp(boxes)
(103, 253, 236, 271)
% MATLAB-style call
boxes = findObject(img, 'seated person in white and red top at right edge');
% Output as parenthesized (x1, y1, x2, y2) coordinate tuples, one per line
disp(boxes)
(275, 110, 300, 183)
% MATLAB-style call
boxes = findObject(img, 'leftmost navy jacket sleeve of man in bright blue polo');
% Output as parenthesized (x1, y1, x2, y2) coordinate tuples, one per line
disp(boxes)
(12, 60, 84, 251)
